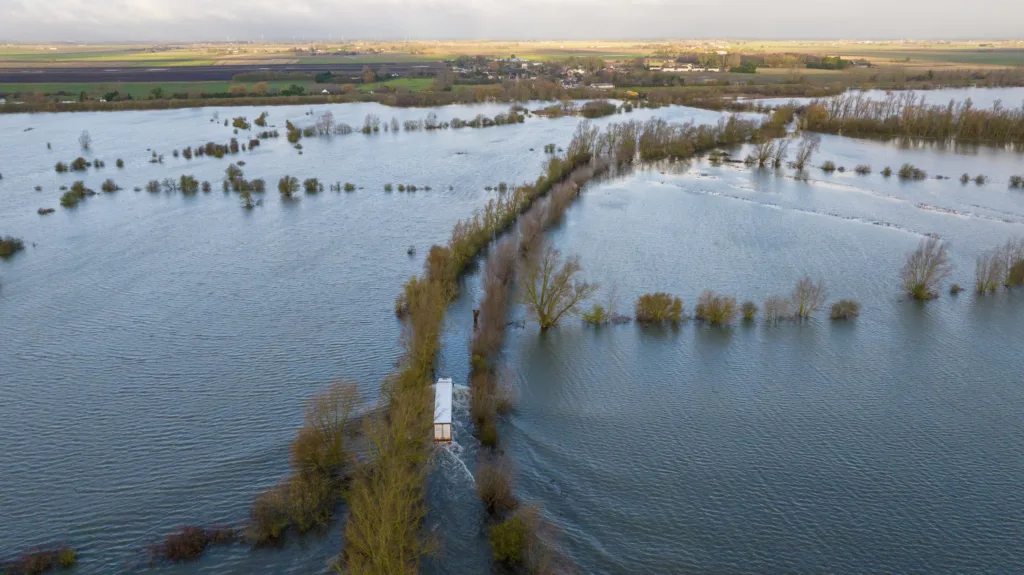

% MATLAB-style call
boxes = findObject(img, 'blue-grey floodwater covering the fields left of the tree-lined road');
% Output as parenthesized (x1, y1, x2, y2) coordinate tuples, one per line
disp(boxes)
(0, 100, 737, 574)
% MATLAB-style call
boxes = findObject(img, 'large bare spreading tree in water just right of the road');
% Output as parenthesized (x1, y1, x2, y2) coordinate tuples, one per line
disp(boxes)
(520, 245, 597, 330)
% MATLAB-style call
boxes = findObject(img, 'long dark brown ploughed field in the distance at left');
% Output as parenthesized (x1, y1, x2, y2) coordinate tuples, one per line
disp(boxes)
(0, 62, 444, 84)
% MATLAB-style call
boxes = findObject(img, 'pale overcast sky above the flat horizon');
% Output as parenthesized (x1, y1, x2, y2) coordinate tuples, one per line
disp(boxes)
(0, 0, 1024, 42)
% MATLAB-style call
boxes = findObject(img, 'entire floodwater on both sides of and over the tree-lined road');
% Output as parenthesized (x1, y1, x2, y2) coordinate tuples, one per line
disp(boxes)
(0, 96, 1024, 573)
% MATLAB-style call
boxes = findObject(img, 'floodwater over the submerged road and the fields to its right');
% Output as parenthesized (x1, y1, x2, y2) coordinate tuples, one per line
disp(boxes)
(435, 130, 1024, 574)
